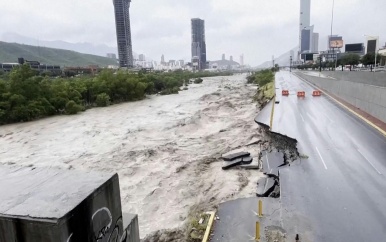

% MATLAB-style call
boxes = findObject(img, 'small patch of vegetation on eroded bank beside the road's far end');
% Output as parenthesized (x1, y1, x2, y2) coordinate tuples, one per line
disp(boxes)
(247, 69, 275, 105)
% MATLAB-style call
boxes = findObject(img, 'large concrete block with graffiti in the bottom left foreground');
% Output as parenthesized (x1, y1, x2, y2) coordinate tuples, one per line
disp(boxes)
(0, 166, 140, 242)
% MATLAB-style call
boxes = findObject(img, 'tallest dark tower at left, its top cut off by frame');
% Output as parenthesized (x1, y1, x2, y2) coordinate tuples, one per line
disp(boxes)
(113, 0, 133, 68)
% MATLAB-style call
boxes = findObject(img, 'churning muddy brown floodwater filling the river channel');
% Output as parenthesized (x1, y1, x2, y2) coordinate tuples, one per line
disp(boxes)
(0, 75, 262, 237)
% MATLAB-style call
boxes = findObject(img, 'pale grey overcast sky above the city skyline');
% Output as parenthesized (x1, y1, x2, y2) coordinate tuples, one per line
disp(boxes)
(0, 0, 386, 65)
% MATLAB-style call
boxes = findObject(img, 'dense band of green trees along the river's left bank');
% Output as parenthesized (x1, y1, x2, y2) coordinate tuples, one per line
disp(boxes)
(0, 65, 229, 125)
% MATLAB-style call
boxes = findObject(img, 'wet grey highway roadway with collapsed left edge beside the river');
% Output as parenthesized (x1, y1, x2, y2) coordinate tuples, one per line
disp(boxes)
(272, 72, 386, 241)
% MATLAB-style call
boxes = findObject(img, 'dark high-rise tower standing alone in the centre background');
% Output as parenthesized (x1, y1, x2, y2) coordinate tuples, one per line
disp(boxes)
(191, 18, 206, 70)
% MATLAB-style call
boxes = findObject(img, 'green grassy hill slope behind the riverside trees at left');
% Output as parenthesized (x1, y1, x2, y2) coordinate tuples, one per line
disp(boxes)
(0, 41, 117, 67)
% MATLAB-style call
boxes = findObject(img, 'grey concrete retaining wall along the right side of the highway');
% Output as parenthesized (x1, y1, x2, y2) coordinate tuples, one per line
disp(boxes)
(296, 72, 386, 122)
